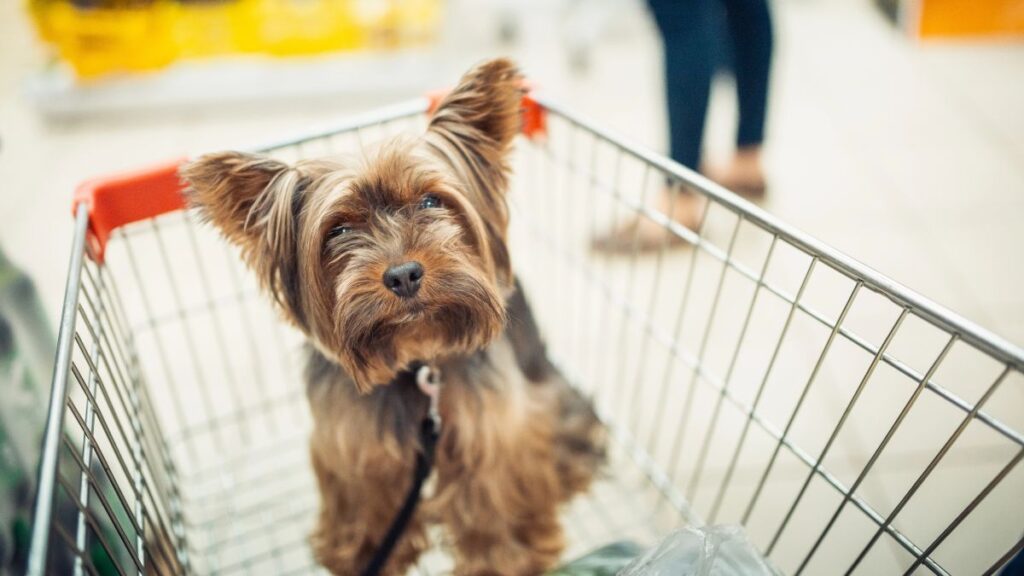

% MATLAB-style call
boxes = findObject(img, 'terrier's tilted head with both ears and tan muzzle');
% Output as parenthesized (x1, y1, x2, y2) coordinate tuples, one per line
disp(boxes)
(181, 59, 522, 392)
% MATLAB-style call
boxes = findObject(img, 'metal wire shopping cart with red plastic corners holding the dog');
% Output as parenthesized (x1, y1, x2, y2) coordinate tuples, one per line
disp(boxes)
(29, 91, 1024, 575)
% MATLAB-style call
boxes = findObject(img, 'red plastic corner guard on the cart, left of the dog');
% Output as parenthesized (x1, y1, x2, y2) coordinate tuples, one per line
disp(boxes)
(72, 158, 185, 263)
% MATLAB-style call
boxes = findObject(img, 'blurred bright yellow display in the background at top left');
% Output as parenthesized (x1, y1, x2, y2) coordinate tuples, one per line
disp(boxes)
(29, 0, 441, 80)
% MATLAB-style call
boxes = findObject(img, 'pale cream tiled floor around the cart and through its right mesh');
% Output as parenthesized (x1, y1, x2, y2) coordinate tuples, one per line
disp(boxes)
(0, 0, 1024, 573)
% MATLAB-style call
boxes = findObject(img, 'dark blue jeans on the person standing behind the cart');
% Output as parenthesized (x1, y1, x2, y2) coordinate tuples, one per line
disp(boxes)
(648, 0, 773, 169)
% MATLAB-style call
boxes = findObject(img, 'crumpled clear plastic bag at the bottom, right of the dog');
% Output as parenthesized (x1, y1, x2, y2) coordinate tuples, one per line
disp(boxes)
(618, 526, 777, 576)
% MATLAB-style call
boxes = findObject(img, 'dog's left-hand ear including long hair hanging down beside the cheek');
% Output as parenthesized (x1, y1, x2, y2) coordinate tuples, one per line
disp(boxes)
(180, 152, 305, 327)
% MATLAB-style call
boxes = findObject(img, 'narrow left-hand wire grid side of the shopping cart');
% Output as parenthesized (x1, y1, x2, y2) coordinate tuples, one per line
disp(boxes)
(43, 239, 187, 574)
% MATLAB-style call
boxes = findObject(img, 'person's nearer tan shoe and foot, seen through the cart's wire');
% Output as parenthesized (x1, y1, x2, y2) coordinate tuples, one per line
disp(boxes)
(591, 189, 706, 254)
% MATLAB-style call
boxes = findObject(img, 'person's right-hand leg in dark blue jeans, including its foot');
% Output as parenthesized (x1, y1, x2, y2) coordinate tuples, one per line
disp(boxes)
(713, 0, 774, 196)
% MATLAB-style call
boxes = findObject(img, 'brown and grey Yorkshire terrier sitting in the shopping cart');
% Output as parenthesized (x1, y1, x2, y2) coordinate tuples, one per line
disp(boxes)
(181, 59, 605, 576)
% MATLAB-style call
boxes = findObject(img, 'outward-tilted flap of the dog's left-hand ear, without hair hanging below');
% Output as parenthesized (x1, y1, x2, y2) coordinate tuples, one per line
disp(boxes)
(180, 152, 289, 248)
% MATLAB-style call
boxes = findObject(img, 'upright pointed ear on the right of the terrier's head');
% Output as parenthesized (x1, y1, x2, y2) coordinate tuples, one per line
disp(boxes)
(426, 58, 525, 286)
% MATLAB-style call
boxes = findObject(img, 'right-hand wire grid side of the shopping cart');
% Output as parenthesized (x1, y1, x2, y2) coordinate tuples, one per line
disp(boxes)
(513, 103, 1024, 574)
